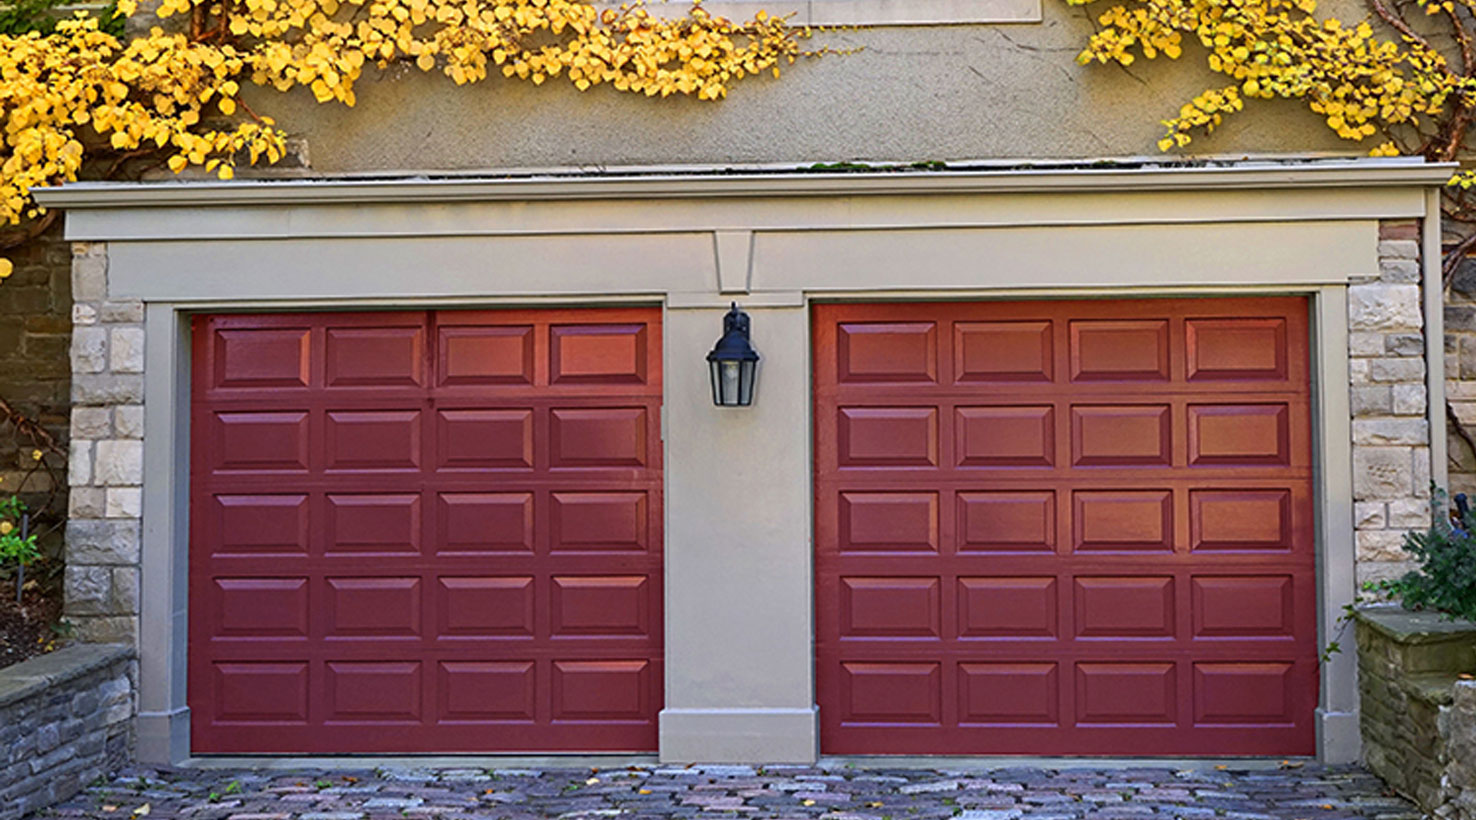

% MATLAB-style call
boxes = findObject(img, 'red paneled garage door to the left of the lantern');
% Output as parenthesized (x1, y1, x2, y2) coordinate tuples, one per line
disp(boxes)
(189, 308, 661, 754)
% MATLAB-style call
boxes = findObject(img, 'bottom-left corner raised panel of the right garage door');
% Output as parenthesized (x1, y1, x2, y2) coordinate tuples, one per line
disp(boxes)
(840, 662, 943, 724)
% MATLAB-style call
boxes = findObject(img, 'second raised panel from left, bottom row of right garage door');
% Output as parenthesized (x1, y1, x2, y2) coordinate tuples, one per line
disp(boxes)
(958, 662, 1061, 726)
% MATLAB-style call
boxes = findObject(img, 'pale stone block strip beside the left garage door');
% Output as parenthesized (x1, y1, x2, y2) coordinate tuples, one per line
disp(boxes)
(66, 243, 143, 646)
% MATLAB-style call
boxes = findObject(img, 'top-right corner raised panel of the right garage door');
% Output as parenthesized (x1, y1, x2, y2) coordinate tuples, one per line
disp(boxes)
(1184, 317, 1287, 382)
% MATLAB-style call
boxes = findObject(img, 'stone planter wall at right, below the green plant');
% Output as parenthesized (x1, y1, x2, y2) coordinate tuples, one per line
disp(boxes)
(1355, 605, 1476, 820)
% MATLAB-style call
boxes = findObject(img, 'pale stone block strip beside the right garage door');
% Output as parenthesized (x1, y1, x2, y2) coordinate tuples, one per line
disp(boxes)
(1348, 220, 1430, 581)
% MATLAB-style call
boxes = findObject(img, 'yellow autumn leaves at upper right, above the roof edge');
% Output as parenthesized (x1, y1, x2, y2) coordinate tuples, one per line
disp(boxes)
(1069, 0, 1476, 156)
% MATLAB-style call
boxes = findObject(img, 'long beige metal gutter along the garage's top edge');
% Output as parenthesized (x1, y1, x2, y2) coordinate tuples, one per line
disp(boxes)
(32, 159, 1457, 209)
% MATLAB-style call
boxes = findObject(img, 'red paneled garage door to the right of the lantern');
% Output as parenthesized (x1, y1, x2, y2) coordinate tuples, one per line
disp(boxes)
(815, 298, 1318, 755)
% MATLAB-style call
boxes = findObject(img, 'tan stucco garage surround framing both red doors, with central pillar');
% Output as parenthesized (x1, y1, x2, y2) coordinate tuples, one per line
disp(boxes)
(40, 162, 1449, 762)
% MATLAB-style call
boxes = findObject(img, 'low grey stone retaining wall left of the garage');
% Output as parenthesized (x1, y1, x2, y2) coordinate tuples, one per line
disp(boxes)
(0, 644, 137, 820)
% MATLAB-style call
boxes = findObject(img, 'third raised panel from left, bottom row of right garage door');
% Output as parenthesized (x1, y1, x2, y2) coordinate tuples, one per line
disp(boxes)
(1076, 662, 1178, 724)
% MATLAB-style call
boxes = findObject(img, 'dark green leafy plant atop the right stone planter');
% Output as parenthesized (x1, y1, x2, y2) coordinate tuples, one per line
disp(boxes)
(1364, 490, 1476, 621)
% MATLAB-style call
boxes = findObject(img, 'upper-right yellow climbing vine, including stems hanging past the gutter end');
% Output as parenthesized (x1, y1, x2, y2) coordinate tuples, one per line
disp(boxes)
(1067, 0, 1476, 265)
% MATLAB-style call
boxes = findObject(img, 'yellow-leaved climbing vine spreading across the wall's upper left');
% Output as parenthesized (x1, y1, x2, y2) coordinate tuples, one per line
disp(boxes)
(0, 0, 818, 279)
